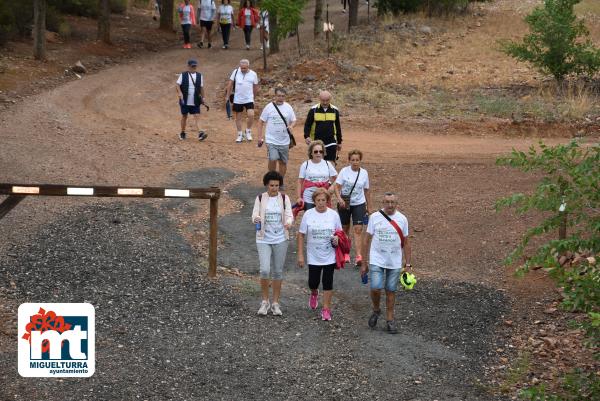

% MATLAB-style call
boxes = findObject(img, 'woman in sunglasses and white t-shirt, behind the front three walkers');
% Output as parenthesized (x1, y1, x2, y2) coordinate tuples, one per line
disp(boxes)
(297, 140, 337, 210)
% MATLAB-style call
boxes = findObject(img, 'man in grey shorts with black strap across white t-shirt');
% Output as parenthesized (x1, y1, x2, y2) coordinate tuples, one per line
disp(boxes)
(258, 88, 296, 190)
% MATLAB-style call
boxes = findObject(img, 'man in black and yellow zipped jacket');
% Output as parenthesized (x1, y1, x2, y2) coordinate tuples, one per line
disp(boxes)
(304, 91, 342, 163)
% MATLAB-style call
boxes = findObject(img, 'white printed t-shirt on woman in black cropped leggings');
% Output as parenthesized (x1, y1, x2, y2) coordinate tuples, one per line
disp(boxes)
(298, 208, 342, 266)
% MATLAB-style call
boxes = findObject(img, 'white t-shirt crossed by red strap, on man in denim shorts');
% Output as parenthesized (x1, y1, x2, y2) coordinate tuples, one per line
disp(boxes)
(367, 211, 408, 269)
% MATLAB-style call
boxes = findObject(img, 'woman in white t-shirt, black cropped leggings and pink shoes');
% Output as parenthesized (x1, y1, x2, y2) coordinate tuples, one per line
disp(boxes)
(298, 188, 342, 320)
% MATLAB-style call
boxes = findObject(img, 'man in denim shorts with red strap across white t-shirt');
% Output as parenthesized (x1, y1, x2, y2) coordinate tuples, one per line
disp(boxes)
(360, 192, 412, 334)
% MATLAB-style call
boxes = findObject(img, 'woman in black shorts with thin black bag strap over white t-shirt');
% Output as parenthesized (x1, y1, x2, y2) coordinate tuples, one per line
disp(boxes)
(335, 149, 371, 266)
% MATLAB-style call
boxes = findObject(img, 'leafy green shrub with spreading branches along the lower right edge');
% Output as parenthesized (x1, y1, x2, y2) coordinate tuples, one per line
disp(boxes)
(496, 141, 600, 400)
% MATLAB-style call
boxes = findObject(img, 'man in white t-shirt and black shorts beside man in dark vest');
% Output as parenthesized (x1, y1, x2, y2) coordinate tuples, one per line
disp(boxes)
(225, 59, 258, 143)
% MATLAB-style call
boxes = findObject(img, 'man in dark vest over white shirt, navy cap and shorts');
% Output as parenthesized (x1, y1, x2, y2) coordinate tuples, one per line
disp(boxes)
(175, 59, 208, 141)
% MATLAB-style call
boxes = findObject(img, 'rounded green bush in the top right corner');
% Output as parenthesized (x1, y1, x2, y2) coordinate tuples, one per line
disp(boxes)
(500, 0, 600, 81)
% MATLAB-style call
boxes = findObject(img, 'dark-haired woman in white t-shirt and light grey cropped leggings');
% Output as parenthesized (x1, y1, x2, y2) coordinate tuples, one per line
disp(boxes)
(252, 171, 294, 316)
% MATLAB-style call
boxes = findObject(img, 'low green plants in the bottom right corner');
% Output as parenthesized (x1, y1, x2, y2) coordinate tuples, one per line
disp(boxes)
(519, 369, 600, 401)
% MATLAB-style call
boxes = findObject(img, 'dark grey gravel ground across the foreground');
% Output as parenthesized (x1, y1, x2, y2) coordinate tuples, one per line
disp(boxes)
(0, 179, 505, 401)
